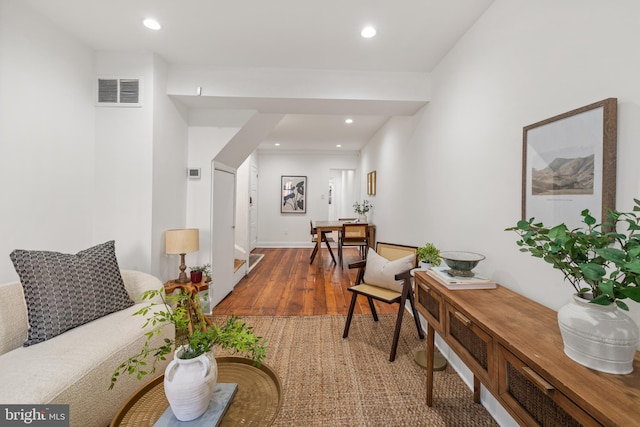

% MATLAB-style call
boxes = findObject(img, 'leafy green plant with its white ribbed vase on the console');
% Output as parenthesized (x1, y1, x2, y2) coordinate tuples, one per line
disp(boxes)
(506, 199, 640, 373)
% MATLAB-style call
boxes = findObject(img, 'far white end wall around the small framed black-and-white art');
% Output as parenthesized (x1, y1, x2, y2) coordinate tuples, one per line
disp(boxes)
(258, 151, 360, 248)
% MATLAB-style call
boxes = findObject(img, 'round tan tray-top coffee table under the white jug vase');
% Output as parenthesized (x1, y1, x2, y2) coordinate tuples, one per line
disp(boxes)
(111, 357, 282, 427)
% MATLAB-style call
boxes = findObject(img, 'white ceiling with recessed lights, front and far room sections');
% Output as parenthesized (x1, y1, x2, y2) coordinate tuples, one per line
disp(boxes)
(26, 0, 493, 150)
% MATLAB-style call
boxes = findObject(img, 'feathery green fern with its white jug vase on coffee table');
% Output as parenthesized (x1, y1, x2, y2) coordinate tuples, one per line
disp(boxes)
(109, 285, 267, 421)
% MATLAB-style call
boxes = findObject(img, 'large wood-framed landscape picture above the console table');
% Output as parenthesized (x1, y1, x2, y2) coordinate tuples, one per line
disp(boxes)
(522, 98, 618, 229)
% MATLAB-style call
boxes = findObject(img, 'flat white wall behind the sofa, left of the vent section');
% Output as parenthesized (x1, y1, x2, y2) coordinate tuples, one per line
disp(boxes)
(0, 0, 98, 283)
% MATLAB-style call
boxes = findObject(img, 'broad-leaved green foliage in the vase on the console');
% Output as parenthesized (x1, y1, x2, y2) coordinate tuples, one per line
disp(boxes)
(506, 199, 640, 310)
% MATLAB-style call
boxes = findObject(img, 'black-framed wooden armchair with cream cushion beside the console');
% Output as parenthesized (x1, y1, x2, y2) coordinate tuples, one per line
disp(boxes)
(342, 242, 424, 362)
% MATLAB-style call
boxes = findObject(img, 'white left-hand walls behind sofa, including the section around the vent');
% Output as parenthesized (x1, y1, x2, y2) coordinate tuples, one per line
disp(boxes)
(0, 0, 186, 283)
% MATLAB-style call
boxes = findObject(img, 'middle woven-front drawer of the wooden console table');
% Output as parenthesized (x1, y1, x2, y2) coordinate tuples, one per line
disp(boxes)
(445, 304, 494, 386)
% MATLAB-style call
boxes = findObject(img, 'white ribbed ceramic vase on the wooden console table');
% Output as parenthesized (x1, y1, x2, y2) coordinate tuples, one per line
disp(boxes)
(558, 295, 640, 374)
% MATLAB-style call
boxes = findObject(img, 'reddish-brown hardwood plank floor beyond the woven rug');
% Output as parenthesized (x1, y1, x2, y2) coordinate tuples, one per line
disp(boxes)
(213, 248, 398, 316)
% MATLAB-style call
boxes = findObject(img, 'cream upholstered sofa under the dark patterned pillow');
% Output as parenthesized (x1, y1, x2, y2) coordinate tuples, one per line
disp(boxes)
(0, 270, 175, 427)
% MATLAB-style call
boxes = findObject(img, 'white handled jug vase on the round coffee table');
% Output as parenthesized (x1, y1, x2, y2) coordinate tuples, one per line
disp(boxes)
(164, 349, 218, 421)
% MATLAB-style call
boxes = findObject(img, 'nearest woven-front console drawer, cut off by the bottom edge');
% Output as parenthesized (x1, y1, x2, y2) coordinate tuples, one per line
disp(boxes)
(498, 345, 601, 427)
